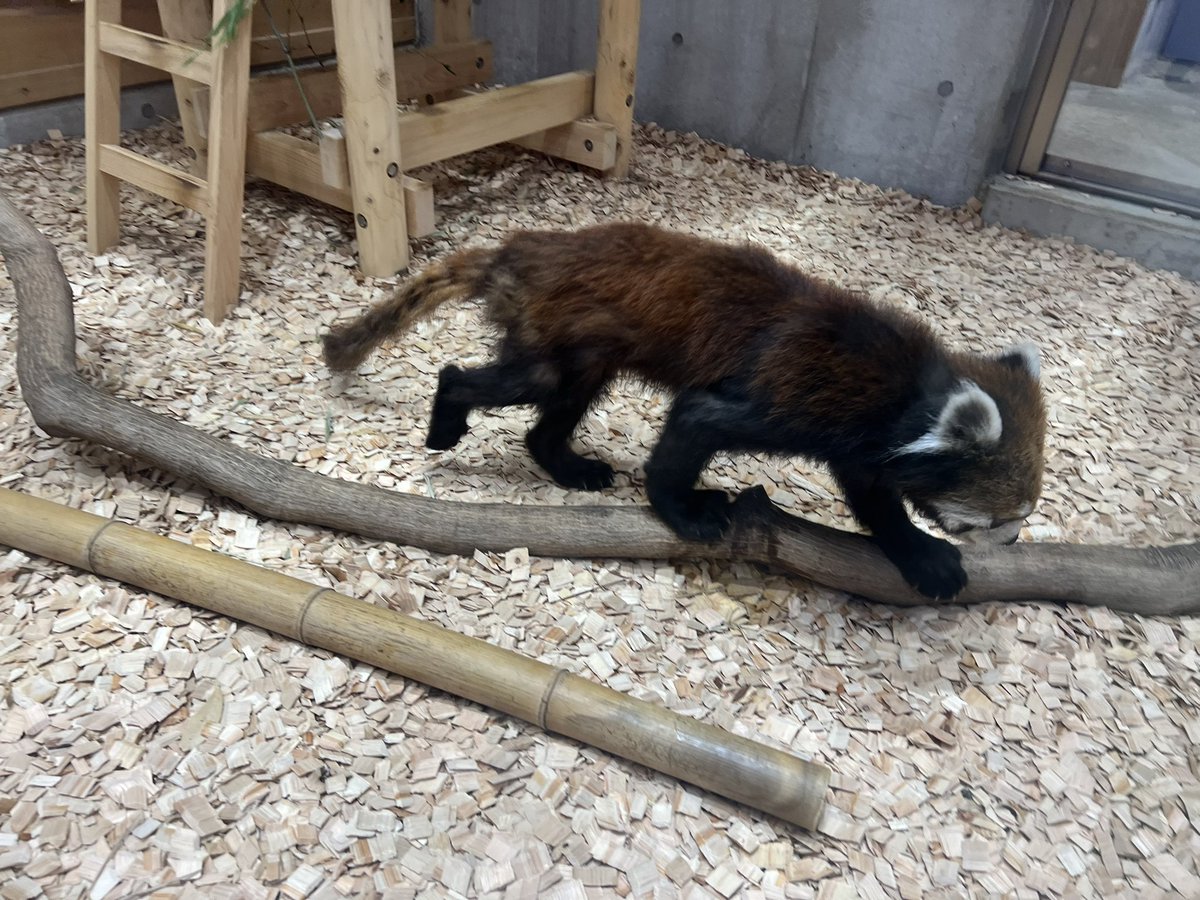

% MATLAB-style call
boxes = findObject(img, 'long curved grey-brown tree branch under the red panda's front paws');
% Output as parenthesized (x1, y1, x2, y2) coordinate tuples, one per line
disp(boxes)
(0, 187, 1200, 614)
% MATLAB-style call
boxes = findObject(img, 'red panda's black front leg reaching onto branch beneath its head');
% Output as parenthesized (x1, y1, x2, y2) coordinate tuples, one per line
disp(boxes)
(834, 467, 967, 600)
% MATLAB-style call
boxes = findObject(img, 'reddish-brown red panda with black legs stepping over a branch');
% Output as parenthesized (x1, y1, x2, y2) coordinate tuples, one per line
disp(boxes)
(324, 223, 1045, 599)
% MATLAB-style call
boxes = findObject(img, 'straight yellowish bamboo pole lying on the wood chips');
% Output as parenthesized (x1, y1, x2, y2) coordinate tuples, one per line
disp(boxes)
(0, 488, 830, 829)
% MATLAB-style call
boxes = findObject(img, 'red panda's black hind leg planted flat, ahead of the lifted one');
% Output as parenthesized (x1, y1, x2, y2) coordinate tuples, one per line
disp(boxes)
(526, 381, 613, 491)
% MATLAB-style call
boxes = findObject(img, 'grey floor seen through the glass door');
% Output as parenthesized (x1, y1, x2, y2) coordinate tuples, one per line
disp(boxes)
(1045, 65, 1200, 208)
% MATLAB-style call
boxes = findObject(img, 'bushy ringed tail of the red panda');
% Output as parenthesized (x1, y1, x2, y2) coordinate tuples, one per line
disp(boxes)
(323, 248, 496, 372)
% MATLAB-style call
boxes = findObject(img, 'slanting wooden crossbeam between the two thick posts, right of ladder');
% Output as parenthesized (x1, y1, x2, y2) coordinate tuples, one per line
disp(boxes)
(398, 72, 597, 169)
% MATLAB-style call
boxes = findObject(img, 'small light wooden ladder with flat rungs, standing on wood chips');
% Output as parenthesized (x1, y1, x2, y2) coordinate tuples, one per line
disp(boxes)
(84, 0, 251, 322)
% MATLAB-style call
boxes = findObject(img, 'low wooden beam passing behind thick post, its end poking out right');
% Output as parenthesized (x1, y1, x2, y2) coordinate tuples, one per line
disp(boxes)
(246, 132, 434, 238)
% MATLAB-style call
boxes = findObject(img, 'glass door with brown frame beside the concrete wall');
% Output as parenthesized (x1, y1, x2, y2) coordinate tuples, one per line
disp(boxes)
(1010, 0, 1200, 216)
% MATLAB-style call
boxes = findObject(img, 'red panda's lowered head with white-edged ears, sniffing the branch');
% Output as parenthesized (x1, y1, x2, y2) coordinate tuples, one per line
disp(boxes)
(893, 344, 1046, 544)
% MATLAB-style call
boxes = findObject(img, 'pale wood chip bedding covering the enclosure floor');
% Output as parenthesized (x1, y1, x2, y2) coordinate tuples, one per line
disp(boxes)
(0, 124, 1200, 900)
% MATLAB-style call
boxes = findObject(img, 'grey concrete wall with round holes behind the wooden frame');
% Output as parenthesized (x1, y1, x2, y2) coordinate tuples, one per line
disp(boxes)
(475, 0, 1051, 204)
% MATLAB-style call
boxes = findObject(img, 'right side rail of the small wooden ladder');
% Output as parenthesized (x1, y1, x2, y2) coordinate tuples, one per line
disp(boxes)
(204, 0, 251, 322)
